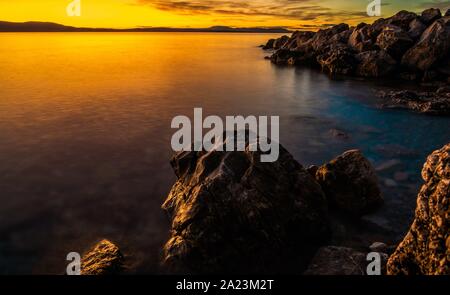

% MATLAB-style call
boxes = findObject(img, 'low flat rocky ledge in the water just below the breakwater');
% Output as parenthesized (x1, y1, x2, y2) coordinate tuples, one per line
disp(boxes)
(379, 87, 450, 116)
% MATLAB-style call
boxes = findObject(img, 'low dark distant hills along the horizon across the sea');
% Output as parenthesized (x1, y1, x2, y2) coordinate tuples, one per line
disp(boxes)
(0, 21, 290, 33)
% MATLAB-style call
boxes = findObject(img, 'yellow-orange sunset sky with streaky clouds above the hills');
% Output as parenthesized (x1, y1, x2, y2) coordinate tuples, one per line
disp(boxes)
(0, 0, 450, 30)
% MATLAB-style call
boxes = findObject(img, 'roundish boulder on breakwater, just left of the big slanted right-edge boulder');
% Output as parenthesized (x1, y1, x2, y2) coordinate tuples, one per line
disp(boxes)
(376, 25, 413, 60)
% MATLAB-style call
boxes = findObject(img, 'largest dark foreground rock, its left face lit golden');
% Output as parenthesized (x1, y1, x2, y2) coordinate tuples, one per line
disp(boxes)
(162, 138, 329, 274)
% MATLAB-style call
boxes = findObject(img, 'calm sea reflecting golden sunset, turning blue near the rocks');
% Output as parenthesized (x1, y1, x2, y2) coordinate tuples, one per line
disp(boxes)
(0, 33, 450, 273)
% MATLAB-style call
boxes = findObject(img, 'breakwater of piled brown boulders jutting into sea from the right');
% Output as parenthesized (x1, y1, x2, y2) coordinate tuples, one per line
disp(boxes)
(264, 8, 450, 114)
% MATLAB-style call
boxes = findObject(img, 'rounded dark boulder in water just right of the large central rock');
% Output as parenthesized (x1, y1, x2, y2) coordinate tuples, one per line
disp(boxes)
(316, 150, 383, 216)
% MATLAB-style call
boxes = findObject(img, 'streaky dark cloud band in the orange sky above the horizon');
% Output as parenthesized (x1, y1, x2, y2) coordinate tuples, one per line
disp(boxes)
(137, 0, 367, 21)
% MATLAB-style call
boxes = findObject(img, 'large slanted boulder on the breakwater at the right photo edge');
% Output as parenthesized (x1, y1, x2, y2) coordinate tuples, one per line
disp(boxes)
(402, 17, 450, 71)
